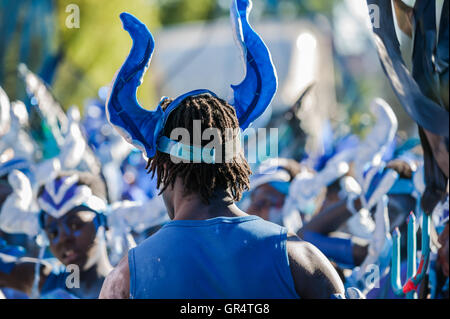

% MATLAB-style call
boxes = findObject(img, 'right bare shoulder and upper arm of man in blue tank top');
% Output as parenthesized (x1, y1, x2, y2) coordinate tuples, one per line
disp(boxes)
(286, 234, 344, 299)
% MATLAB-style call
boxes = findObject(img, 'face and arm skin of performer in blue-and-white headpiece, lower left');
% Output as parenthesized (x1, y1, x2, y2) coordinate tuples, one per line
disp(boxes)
(0, 207, 112, 298)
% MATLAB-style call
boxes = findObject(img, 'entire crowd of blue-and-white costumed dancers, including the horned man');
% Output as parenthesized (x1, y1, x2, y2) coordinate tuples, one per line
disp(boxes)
(0, 0, 449, 299)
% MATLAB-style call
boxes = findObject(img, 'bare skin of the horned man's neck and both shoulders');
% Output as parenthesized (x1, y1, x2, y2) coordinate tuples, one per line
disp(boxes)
(100, 178, 344, 299)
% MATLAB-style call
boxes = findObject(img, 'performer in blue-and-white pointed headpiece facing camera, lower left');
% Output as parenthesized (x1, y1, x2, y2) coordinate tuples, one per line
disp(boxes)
(0, 171, 112, 298)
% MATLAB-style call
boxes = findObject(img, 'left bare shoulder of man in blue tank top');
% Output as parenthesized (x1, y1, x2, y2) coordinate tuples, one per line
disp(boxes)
(99, 254, 130, 299)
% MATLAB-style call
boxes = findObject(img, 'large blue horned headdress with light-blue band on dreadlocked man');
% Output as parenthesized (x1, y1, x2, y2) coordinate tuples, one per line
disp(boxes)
(106, 0, 277, 163)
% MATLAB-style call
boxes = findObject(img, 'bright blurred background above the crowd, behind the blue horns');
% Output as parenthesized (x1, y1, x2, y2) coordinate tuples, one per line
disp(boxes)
(0, 0, 415, 164)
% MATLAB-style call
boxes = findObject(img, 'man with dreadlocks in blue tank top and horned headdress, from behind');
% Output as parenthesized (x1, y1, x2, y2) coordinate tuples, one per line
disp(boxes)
(100, 0, 344, 299)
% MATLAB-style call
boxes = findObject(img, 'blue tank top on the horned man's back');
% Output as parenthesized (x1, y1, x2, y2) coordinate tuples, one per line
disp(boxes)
(128, 216, 299, 299)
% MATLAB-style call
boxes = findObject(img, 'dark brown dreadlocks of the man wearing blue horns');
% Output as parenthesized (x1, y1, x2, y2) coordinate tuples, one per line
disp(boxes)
(146, 94, 251, 204)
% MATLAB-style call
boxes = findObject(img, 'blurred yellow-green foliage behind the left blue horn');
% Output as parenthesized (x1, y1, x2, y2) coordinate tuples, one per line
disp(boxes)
(53, 0, 159, 108)
